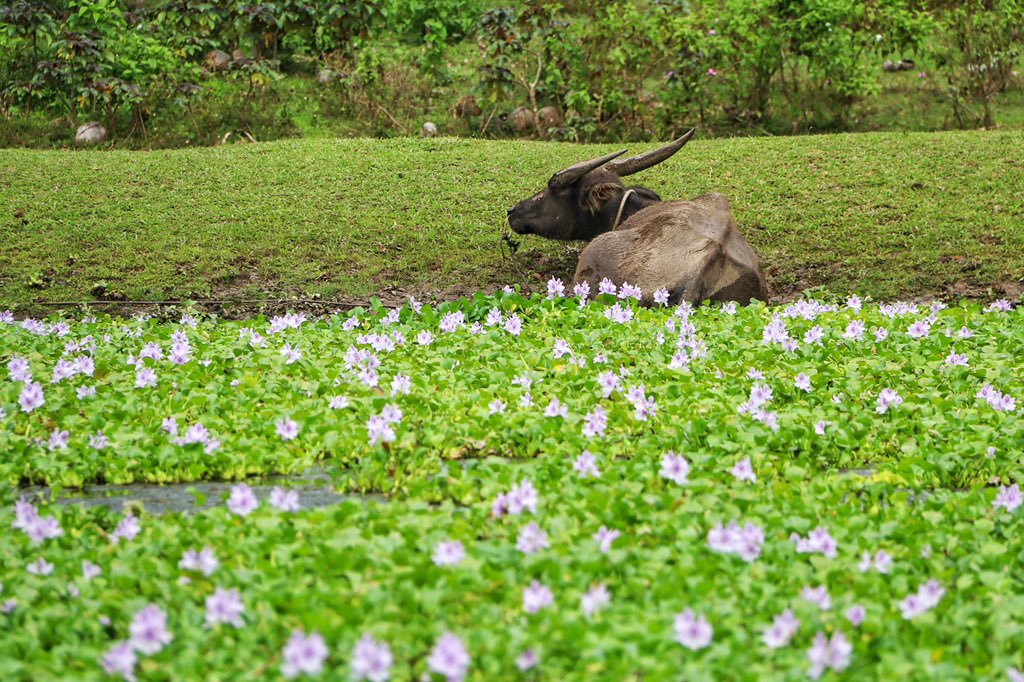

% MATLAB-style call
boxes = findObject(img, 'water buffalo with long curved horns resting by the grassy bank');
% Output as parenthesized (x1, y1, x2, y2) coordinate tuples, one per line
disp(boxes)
(508, 130, 768, 305)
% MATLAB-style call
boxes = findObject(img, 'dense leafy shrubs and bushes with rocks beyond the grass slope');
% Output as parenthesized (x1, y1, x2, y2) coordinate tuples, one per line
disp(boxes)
(0, 0, 1024, 147)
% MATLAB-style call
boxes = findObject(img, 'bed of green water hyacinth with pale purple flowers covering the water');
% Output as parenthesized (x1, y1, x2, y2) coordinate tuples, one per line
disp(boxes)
(0, 283, 1024, 682)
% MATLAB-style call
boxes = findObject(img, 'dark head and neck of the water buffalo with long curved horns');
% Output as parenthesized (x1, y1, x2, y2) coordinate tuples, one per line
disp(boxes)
(508, 129, 694, 240)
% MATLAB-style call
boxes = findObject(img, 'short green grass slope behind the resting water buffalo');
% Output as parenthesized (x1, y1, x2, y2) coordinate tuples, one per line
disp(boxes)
(0, 131, 1024, 311)
